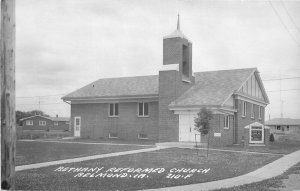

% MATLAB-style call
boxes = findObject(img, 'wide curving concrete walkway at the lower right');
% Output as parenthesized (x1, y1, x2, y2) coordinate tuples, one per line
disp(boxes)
(148, 150, 300, 191)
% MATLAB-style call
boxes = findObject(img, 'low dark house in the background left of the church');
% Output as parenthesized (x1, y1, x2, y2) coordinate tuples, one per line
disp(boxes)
(21, 115, 70, 131)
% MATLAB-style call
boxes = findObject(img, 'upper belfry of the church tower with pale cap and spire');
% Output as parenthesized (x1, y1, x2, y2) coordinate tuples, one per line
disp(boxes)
(163, 14, 193, 82)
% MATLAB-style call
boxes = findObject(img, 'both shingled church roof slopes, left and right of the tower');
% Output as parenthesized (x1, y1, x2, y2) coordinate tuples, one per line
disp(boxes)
(62, 68, 256, 106)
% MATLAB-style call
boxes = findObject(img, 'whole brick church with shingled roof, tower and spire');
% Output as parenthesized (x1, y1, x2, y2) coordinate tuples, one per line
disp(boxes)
(62, 19, 269, 146)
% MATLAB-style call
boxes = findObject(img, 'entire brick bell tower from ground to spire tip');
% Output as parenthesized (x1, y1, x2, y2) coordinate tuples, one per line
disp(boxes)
(158, 15, 195, 142)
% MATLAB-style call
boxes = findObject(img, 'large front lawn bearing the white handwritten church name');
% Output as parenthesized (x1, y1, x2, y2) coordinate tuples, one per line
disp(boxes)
(16, 148, 280, 190)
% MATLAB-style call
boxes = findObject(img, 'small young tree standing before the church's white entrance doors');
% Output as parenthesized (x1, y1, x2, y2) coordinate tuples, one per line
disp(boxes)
(194, 107, 213, 156)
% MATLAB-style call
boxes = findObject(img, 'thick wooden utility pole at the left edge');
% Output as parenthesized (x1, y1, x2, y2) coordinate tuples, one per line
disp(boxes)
(0, 0, 16, 190)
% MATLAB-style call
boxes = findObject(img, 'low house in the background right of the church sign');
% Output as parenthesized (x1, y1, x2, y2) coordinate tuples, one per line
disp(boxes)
(266, 118, 300, 141)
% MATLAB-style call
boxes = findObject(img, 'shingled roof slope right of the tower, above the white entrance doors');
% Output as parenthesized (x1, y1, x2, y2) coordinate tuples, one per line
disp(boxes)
(169, 68, 256, 107)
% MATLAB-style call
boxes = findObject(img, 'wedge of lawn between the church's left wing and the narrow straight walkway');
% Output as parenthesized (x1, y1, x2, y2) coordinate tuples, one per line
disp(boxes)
(16, 141, 154, 166)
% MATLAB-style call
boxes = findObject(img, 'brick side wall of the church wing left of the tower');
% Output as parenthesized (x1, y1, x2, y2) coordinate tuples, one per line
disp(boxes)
(71, 102, 158, 140)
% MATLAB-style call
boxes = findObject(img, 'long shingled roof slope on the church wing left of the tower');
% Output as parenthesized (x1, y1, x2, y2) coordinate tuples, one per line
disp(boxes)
(62, 75, 158, 100)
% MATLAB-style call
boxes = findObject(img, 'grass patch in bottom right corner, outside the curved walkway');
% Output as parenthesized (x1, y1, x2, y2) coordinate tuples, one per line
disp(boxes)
(215, 163, 300, 191)
